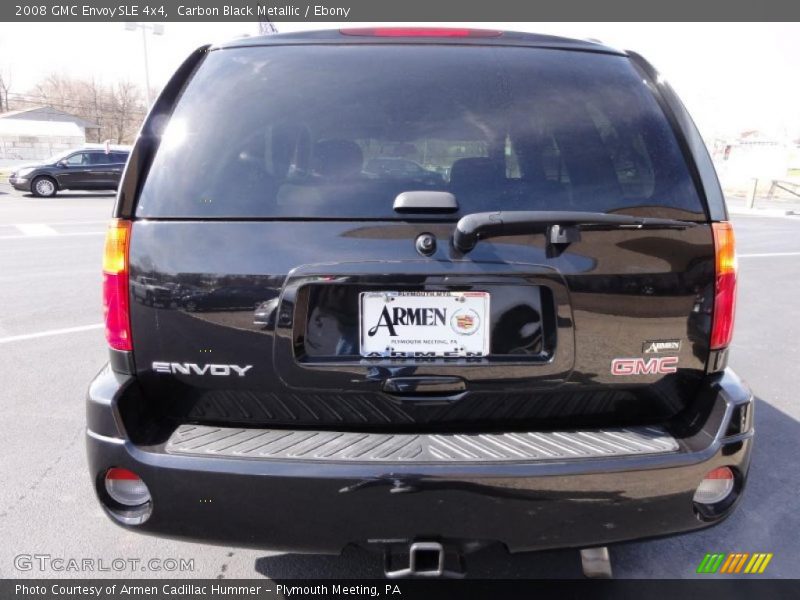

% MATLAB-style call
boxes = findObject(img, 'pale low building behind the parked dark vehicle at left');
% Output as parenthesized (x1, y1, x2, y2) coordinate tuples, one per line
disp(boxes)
(0, 106, 99, 161)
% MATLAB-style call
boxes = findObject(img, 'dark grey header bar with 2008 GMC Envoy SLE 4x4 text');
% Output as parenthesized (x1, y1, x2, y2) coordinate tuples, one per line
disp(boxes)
(0, 0, 800, 21)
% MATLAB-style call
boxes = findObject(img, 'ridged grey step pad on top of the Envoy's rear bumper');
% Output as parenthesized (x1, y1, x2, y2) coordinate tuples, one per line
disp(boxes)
(166, 425, 678, 463)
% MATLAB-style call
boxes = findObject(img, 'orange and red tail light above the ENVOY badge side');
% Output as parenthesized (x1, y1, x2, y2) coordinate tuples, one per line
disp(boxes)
(103, 219, 133, 351)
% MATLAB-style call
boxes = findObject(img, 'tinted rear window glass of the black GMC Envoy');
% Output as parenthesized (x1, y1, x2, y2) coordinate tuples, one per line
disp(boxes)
(137, 45, 703, 219)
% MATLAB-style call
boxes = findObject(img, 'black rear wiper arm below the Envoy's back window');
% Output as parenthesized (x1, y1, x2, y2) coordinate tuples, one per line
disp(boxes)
(453, 210, 697, 254)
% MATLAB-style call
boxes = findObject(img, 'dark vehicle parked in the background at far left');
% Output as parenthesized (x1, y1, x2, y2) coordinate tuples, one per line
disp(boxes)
(8, 148, 129, 197)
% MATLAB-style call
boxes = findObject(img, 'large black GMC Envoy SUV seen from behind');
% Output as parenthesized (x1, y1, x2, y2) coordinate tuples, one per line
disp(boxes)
(87, 29, 753, 576)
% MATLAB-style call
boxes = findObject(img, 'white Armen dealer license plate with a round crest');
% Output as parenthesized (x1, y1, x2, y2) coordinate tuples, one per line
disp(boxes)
(359, 292, 490, 358)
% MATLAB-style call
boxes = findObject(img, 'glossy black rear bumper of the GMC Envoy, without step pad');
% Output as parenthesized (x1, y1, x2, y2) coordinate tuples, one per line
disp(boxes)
(87, 369, 752, 553)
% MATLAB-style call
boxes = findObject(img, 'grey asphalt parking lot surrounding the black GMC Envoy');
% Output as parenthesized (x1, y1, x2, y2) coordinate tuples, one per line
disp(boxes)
(0, 183, 800, 578)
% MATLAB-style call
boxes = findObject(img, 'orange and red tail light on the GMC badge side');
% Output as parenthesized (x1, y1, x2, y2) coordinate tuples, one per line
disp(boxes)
(711, 222, 736, 350)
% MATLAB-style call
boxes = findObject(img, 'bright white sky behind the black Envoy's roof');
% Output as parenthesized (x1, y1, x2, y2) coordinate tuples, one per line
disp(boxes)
(0, 22, 800, 138)
